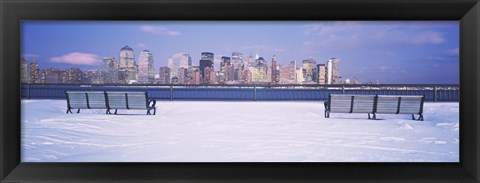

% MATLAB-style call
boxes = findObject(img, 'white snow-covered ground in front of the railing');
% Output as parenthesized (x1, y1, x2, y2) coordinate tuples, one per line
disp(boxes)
(21, 100, 459, 162)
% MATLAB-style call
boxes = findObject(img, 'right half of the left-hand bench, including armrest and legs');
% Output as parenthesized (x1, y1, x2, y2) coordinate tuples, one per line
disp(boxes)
(105, 91, 157, 115)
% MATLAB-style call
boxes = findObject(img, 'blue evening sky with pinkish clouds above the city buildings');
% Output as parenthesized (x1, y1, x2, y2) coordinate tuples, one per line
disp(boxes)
(22, 21, 459, 84)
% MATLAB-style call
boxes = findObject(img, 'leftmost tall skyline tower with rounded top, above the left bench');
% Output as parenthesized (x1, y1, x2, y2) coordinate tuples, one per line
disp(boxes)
(118, 46, 137, 83)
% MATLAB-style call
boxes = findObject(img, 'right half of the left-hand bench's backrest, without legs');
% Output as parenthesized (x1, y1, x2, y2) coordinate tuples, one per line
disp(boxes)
(105, 92, 148, 109)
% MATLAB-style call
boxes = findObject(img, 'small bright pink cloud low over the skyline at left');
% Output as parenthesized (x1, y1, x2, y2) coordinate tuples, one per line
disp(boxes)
(50, 52, 101, 65)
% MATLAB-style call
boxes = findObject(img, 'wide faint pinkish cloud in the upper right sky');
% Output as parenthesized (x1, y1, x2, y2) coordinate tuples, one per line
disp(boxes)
(303, 21, 446, 47)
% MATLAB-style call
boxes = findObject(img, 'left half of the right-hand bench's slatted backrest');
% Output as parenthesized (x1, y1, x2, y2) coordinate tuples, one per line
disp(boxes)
(329, 94, 375, 113)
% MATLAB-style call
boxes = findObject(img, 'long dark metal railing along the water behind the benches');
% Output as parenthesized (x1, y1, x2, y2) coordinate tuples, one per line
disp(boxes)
(21, 84, 460, 101)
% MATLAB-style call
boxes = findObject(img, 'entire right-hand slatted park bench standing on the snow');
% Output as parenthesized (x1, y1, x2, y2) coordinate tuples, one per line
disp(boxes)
(324, 94, 425, 121)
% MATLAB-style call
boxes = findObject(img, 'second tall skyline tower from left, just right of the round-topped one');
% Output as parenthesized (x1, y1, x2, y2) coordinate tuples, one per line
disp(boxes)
(138, 50, 155, 83)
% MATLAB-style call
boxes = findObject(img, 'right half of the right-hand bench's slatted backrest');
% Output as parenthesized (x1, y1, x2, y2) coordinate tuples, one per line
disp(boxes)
(375, 95, 425, 114)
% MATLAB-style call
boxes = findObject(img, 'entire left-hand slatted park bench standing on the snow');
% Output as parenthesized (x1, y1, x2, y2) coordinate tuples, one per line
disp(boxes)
(65, 91, 156, 115)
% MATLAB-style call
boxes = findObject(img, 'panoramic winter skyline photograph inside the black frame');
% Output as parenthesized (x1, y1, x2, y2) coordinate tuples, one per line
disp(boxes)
(19, 21, 460, 162)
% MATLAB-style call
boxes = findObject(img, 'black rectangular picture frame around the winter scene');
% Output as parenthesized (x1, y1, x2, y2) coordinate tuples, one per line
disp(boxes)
(0, 0, 480, 182)
